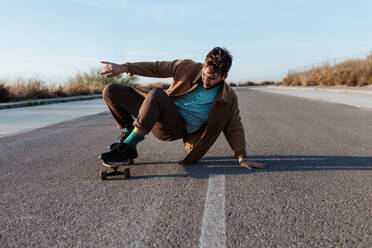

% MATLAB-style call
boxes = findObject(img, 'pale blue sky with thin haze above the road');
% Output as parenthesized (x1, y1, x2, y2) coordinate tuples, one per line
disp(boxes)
(0, 0, 372, 83)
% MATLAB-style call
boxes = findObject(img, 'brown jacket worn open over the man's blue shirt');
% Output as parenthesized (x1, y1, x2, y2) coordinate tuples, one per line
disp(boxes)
(126, 60, 246, 164)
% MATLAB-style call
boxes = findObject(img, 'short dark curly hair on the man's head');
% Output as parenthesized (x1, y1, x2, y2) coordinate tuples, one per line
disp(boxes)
(204, 47, 232, 76)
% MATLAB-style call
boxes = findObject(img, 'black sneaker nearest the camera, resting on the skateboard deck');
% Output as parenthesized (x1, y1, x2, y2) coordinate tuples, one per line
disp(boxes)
(99, 143, 138, 162)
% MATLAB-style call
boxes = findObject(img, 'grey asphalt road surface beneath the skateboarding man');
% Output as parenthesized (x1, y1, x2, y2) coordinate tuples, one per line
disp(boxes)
(0, 90, 372, 247)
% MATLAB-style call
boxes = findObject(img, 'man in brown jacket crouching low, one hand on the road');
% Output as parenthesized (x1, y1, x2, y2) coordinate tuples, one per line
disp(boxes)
(100, 47, 265, 169)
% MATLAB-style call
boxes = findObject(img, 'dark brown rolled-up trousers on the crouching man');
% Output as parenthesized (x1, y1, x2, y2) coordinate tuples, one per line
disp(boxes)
(102, 84, 186, 141)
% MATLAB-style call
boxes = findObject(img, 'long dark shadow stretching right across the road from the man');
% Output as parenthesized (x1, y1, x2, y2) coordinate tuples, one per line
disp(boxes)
(107, 155, 372, 180)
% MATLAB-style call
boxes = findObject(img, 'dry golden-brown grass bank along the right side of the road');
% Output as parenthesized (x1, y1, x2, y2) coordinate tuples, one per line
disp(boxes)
(282, 54, 372, 86)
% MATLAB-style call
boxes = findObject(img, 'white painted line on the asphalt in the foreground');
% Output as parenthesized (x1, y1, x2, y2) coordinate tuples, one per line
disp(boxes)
(199, 175, 226, 248)
